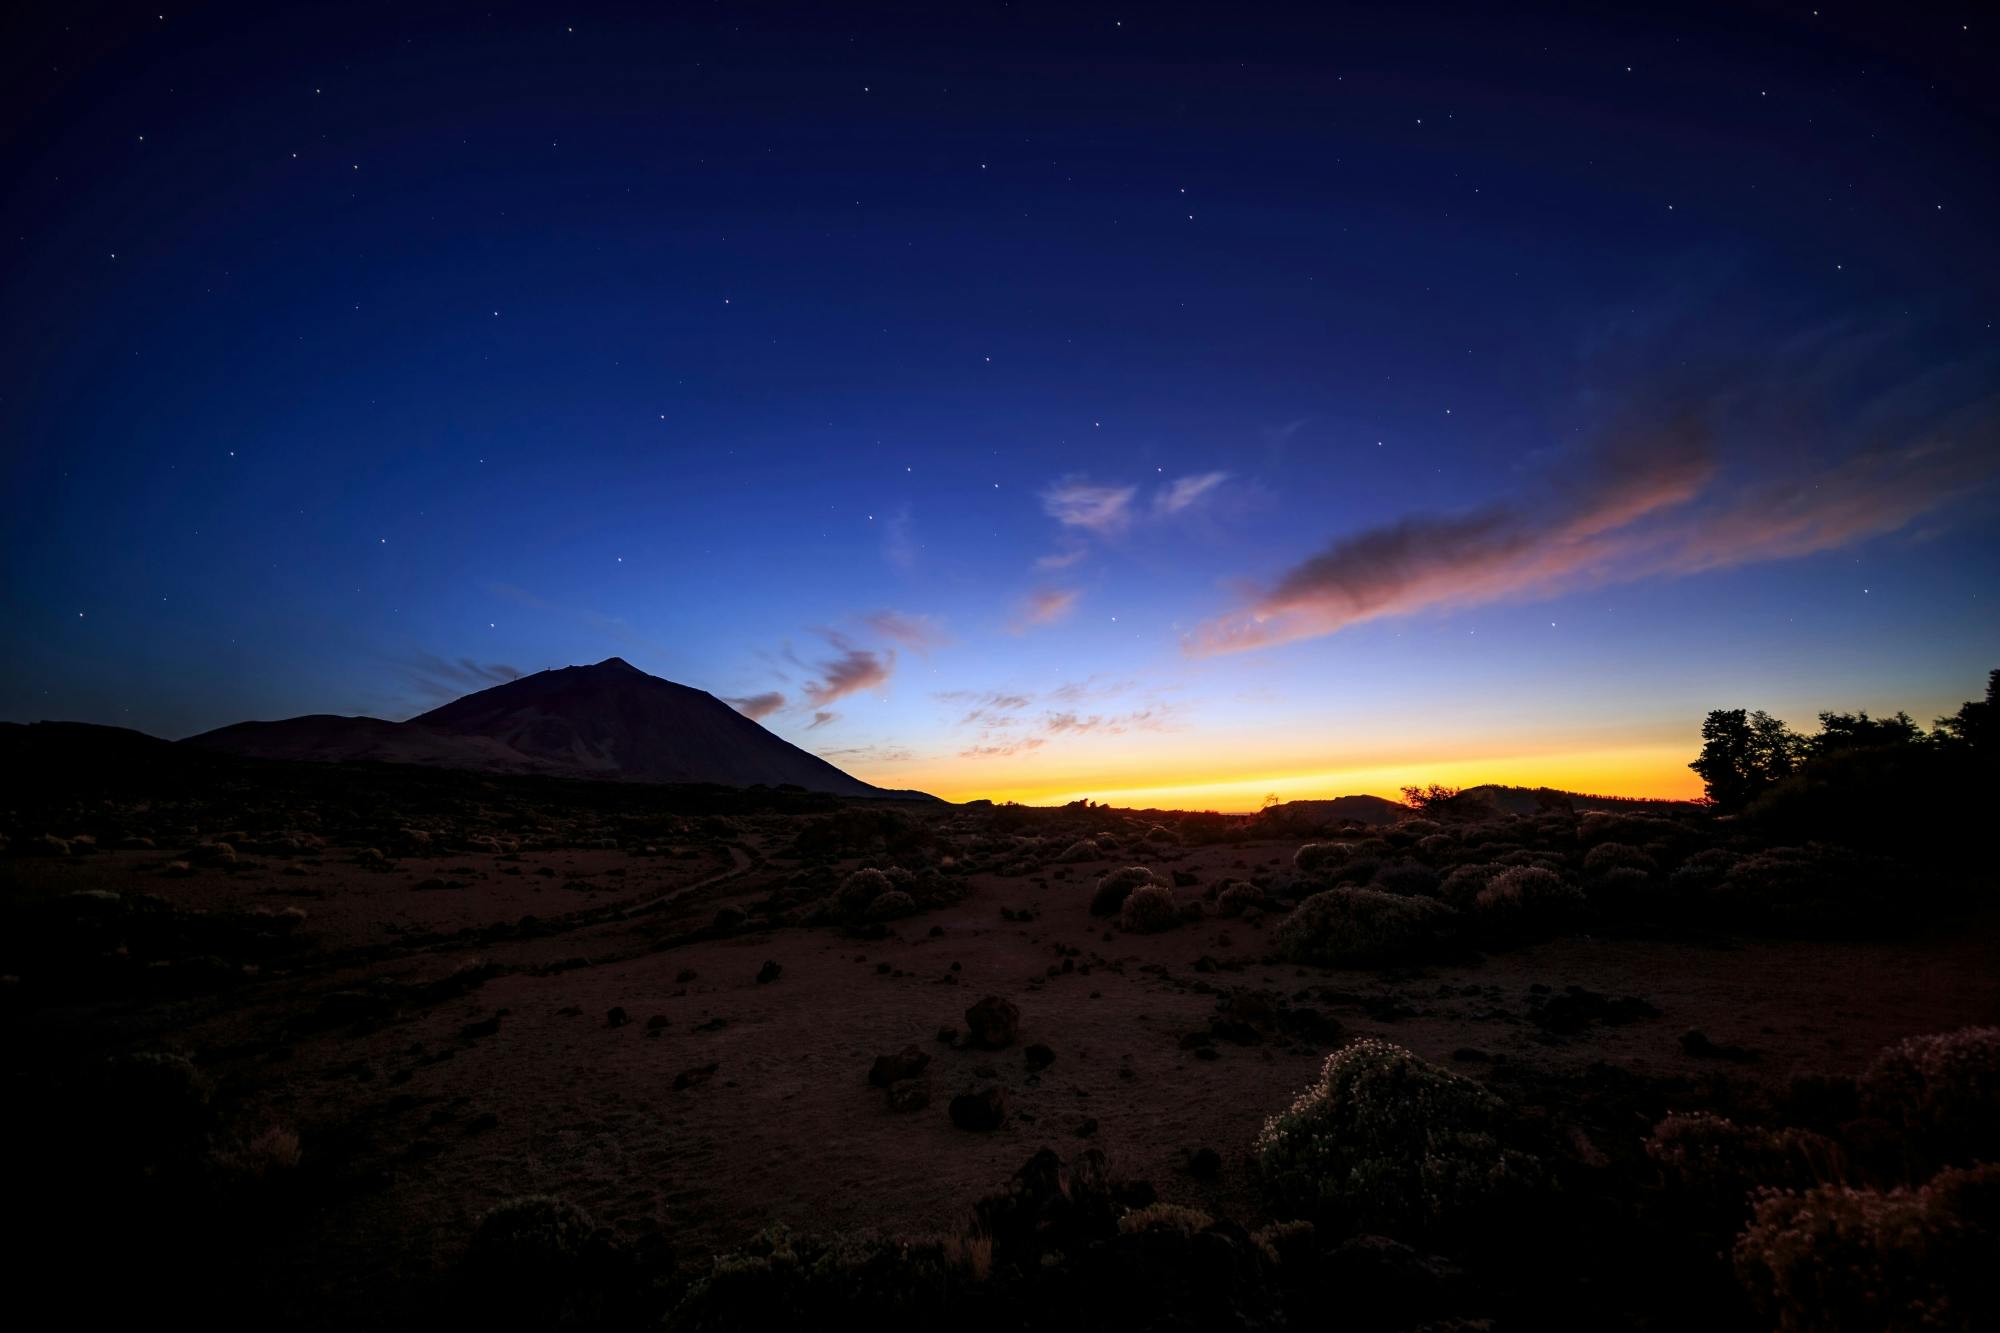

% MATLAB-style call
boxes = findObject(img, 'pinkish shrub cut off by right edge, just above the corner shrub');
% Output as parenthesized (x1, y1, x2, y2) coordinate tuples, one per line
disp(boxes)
(1860, 1027, 2000, 1169)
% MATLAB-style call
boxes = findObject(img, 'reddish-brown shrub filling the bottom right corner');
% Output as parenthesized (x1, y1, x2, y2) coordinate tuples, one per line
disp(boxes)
(1734, 1163, 2000, 1333)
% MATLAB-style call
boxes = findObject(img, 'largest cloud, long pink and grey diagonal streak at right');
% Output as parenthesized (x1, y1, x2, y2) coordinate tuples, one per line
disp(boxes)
(1184, 410, 1990, 656)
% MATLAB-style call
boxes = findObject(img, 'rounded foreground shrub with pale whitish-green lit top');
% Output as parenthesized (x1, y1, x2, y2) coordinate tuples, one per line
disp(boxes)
(1254, 1039, 1536, 1235)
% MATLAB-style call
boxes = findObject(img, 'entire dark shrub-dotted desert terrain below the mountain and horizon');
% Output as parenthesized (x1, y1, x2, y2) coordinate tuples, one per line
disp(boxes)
(0, 735, 2000, 1329)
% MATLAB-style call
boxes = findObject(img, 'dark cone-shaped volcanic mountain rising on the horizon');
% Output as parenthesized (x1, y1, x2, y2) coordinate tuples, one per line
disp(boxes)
(182, 656, 930, 801)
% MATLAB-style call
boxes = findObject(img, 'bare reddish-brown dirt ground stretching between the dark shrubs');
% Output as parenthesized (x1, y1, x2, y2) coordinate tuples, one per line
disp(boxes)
(4, 819, 2000, 1325)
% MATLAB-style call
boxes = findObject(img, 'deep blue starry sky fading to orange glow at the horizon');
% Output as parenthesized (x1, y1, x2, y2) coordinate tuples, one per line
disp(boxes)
(0, 4, 2000, 809)
